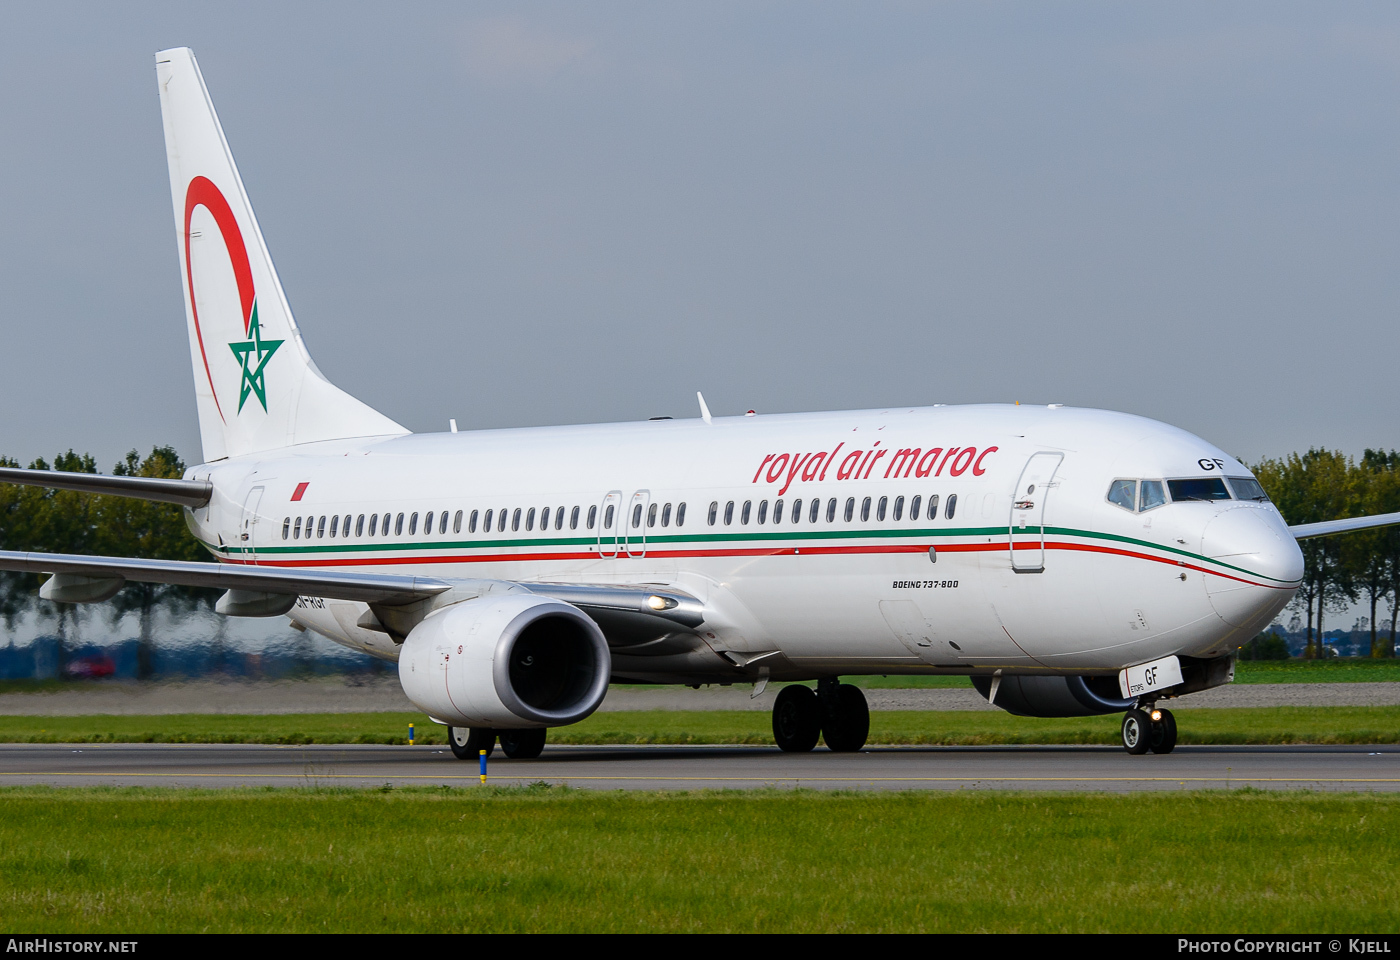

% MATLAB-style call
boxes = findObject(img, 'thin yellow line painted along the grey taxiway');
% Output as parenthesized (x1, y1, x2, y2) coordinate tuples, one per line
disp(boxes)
(0, 771, 1400, 784)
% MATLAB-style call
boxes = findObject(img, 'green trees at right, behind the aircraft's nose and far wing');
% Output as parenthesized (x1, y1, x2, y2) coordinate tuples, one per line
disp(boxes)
(1253, 449, 1400, 658)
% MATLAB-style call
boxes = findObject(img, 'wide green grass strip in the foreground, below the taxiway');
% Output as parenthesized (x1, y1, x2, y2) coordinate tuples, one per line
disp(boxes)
(0, 788, 1400, 935)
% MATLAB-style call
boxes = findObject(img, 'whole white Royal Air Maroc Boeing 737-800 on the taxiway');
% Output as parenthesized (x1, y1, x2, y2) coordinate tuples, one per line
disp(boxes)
(0, 48, 1400, 757)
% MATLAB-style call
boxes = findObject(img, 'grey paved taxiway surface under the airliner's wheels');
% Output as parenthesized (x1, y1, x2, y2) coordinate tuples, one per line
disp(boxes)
(0, 743, 1400, 792)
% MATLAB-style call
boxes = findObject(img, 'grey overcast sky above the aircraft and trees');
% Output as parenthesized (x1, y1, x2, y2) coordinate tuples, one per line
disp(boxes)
(0, 0, 1400, 469)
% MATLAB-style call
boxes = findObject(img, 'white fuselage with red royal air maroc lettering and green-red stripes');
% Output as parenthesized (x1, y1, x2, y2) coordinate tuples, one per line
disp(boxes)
(188, 404, 1302, 683)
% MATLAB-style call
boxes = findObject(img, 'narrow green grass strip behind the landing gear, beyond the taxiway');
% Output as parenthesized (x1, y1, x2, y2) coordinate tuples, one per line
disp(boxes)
(10, 707, 1400, 746)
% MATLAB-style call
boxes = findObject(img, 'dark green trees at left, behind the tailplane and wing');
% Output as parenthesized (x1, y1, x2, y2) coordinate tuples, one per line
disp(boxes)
(0, 446, 207, 675)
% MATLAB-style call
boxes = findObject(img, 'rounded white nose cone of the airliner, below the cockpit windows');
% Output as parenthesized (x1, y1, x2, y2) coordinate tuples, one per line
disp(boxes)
(1201, 505, 1303, 630)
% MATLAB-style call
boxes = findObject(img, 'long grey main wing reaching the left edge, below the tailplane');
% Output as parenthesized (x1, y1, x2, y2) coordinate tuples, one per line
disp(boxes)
(0, 550, 451, 605)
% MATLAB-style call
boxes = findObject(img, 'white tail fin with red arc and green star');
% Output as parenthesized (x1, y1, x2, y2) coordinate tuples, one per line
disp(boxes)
(155, 46, 409, 462)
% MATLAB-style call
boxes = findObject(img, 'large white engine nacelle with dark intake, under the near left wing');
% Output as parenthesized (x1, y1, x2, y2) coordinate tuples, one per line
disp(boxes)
(399, 593, 612, 729)
